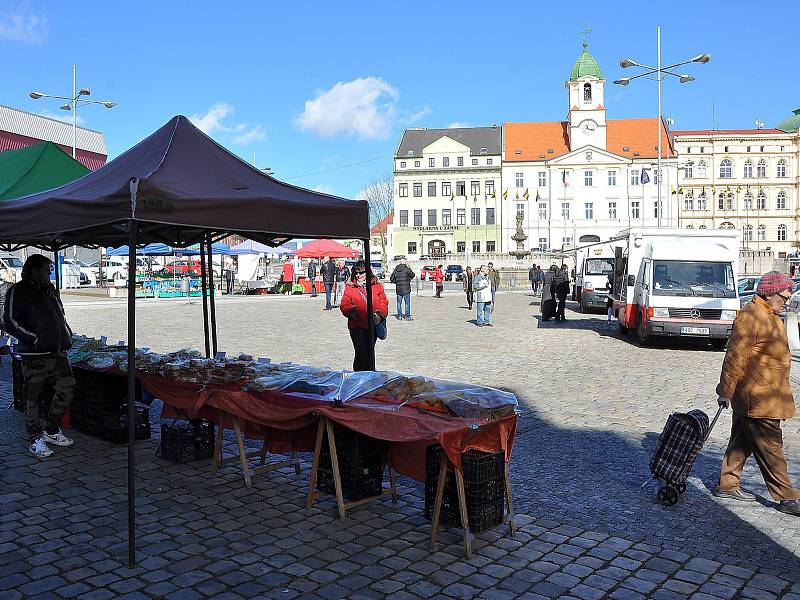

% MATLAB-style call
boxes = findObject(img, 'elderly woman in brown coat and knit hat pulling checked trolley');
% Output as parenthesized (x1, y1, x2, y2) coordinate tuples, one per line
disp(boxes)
(714, 271, 800, 516)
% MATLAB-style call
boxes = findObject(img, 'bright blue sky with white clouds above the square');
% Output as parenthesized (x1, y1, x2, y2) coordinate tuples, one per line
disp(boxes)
(0, 0, 800, 202)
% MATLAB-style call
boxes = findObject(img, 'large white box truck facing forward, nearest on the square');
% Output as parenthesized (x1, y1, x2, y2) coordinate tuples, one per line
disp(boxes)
(612, 228, 741, 348)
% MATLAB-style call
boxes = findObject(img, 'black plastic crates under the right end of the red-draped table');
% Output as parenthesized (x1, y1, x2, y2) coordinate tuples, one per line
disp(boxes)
(425, 445, 506, 533)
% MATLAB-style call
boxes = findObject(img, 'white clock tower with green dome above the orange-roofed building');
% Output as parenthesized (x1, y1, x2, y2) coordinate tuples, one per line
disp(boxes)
(566, 42, 606, 151)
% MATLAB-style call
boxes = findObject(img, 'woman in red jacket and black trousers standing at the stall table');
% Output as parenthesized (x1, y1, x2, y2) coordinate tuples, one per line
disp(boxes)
(339, 260, 389, 371)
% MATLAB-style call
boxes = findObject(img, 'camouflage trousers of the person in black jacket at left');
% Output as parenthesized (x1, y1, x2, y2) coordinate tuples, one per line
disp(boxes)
(21, 354, 75, 442)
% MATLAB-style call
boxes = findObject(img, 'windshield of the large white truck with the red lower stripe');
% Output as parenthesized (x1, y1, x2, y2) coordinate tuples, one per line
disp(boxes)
(653, 260, 736, 298)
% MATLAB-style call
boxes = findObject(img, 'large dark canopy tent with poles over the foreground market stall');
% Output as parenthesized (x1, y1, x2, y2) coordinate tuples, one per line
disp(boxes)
(0, 116, 375, 565)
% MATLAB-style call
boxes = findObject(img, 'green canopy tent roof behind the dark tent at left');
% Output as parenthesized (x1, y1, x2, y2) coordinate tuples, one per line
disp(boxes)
(0, 142, 89, 201)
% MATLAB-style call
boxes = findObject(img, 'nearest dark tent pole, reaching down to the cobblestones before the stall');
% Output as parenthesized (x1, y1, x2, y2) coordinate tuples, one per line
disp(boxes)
(128, 219, 137, 568)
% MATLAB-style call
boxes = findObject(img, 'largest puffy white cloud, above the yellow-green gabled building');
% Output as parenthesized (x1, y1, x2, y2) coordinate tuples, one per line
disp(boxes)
(296, 77, 400, 139)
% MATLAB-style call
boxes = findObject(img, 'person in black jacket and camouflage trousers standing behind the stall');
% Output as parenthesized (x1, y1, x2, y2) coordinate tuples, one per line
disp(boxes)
(3, 254, 75, 458)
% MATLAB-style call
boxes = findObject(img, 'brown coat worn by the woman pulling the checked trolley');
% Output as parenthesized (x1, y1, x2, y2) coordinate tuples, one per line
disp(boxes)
(717, 296, 796, 419)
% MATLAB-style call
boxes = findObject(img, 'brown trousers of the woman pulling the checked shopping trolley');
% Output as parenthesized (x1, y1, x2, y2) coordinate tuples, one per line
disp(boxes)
(719, 413, 800, 501)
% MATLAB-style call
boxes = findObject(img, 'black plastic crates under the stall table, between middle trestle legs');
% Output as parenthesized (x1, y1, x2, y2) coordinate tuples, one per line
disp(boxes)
(317, 425, 389, 502)
